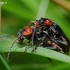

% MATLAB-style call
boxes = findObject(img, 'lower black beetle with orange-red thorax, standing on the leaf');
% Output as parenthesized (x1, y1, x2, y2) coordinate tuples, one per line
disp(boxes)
(7, 23, 62, 60)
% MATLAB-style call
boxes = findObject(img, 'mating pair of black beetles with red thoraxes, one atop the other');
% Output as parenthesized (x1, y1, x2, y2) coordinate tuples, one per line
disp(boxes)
(8, 18, 70, 60)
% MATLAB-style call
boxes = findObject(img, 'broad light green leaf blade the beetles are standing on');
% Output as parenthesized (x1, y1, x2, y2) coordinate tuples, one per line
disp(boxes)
(0, 36, 70, 63)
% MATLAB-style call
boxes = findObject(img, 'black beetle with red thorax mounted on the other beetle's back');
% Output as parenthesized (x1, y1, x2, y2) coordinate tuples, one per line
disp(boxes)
(32, 18, 70, 54)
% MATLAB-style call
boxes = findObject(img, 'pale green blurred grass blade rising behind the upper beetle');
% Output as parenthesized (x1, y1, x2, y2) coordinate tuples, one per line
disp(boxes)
(36, 0, 50, 19)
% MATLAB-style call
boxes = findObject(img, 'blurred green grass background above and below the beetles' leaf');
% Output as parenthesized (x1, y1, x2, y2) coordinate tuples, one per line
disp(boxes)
(2, 0, 70, 70)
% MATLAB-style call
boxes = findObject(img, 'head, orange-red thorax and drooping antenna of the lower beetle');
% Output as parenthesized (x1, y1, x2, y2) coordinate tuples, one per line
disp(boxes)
(7, 26, 33, 60)
